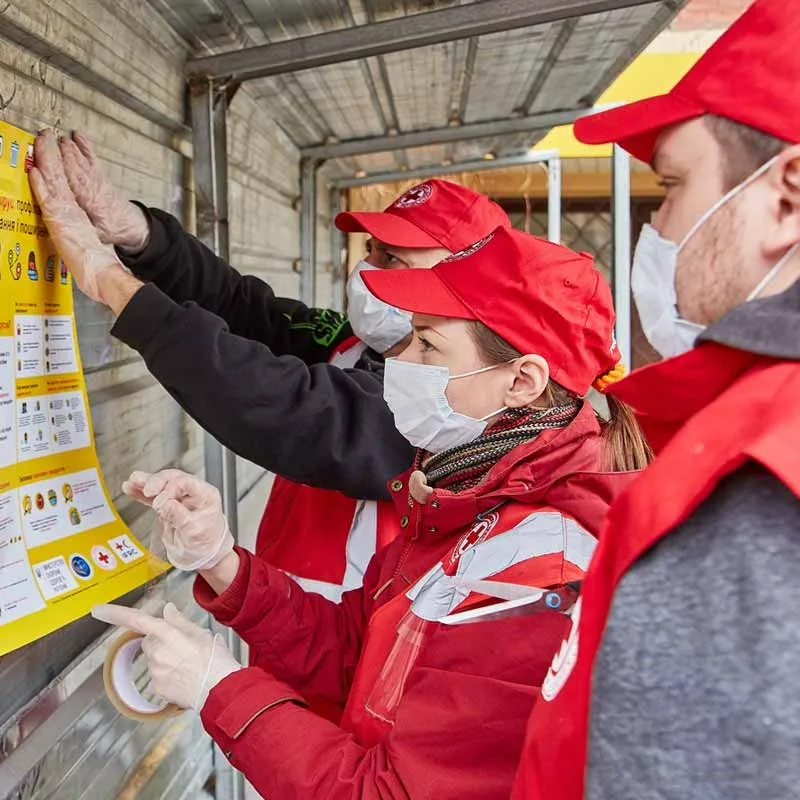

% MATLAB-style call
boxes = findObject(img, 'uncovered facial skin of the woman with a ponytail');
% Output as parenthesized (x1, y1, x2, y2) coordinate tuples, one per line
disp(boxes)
(398, 314, 520, 419)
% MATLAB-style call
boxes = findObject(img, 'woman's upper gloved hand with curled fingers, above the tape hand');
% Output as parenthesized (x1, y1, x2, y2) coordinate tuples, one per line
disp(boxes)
(122, 469, 234, 572)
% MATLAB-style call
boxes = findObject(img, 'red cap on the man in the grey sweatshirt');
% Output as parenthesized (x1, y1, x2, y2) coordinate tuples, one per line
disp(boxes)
(574, 0, 800, 163)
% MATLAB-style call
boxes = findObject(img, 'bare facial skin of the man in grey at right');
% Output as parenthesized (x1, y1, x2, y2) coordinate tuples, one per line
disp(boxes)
(652, 118, 791, 325)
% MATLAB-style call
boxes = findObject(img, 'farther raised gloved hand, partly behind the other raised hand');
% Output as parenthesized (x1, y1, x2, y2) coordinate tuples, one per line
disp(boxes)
(58, 131, 150, 252)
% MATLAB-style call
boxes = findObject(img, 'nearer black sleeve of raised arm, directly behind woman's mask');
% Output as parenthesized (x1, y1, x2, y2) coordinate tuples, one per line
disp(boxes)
(112, 284, 414, 499)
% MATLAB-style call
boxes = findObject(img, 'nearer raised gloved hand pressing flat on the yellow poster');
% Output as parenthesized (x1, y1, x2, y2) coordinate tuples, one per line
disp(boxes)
(30, 131, 124, 302)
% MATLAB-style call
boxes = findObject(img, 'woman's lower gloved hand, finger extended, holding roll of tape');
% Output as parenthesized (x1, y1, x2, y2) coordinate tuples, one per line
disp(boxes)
(92, 603, 243, 712)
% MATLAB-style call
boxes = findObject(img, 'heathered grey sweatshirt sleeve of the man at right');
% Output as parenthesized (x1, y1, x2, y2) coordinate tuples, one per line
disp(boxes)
(586, 464, 800, 800)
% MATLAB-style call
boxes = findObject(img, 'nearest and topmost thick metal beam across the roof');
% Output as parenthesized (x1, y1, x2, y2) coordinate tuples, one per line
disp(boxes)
(186, 0, 664, 81)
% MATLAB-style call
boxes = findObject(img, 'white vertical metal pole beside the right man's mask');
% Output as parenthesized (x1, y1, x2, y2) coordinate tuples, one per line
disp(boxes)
(611, 145, 632, 369)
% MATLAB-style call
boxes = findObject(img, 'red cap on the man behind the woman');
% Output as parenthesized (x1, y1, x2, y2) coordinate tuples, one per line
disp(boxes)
(335, 179, 511, 253)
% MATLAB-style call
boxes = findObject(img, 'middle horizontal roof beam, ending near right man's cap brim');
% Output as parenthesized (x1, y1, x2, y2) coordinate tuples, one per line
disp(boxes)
(300, 108, 598, 160)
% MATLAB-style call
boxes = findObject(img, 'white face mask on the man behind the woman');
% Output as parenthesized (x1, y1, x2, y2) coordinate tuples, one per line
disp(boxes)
(347, 261, 412, 353)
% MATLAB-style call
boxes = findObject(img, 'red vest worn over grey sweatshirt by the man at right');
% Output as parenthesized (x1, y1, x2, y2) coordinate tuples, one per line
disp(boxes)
(512, 344, 800, 800)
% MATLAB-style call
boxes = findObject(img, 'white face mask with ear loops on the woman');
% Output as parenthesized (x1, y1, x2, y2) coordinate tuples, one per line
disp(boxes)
(383, 358, 505, 453)
